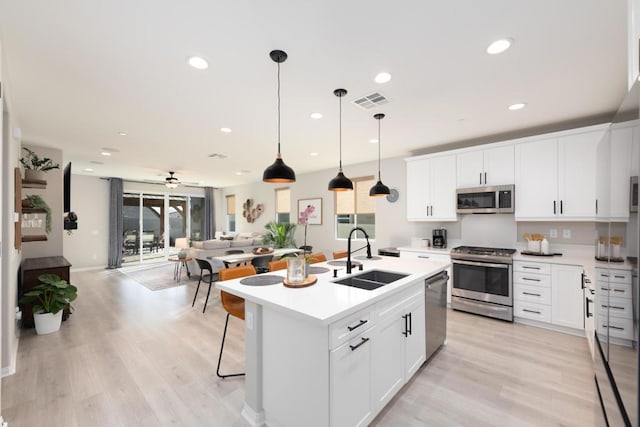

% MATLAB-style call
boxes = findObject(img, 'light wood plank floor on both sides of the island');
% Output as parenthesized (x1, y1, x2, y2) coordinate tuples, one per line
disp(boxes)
(2, 271, 600, 427)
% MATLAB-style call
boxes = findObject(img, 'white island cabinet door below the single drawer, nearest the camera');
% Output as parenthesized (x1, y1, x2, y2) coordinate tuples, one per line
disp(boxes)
(330, 332, 375, 426)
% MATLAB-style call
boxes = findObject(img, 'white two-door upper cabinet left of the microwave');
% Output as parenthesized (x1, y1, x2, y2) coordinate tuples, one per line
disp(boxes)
(407, 155, 457, 221)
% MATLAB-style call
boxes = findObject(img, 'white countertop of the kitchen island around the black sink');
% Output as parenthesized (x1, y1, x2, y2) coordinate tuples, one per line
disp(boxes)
(216, 256, 450, 325)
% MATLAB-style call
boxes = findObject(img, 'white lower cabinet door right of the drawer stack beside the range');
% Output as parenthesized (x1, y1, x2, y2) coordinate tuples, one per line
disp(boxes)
(551, 265, 584, 329)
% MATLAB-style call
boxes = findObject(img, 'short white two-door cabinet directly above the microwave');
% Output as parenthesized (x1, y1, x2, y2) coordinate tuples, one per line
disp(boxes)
(456, 145, 514, 188)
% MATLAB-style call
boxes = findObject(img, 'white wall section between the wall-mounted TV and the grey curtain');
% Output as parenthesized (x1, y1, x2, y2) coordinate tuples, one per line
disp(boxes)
(63, 175, 109, 270)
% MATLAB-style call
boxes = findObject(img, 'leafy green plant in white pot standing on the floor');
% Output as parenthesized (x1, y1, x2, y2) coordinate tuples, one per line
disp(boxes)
(20, 274, 78, 335)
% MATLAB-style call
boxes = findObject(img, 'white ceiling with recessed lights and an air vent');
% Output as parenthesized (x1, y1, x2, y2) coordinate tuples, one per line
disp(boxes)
(0, 0, 627, 187)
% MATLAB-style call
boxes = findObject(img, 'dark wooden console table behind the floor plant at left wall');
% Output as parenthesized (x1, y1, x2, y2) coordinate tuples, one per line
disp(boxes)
(20, 256, 71, 328)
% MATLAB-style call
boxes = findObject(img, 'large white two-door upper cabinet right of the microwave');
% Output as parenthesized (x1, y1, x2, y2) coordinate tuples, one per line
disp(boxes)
(515, 127, 605, 221)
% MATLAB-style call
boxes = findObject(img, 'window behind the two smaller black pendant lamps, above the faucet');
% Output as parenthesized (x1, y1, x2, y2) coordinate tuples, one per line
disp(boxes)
(335, 176, 376, 239)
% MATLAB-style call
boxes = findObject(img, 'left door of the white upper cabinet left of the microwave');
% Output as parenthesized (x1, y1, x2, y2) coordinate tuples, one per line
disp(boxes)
(407, 159, 431, 221)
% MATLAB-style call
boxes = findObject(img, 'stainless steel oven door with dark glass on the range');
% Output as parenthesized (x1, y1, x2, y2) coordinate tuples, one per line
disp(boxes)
(451, 259, 513, 306)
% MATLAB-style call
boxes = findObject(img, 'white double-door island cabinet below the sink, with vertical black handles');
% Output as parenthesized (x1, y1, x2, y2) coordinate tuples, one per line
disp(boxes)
(371, 283, 426, 410)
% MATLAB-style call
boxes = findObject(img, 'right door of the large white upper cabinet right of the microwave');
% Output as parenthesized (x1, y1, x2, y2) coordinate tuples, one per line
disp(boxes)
(558, 131, 604, 219)
